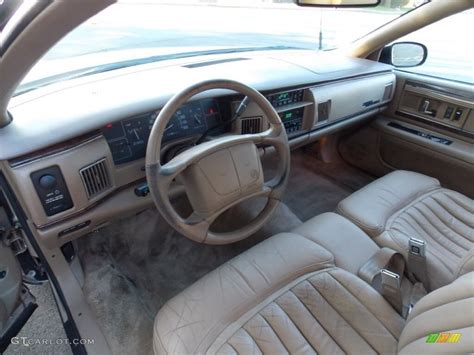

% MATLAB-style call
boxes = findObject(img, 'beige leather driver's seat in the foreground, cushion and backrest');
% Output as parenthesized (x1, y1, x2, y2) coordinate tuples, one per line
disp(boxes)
(153, 233, 474, 354)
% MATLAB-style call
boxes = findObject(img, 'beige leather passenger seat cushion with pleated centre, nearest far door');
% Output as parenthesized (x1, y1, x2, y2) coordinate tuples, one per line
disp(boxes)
(337, 170, 474, 289)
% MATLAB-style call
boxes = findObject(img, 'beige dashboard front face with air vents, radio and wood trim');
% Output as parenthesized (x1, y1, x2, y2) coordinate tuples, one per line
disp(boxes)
(2, 52, 395, 249)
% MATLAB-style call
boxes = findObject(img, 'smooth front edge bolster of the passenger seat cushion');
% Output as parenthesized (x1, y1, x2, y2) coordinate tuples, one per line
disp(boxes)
(337, 170, 440, 237)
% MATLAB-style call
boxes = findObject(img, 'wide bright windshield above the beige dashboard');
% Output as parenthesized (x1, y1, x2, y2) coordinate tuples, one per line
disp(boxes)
(17, 0, 424, 94)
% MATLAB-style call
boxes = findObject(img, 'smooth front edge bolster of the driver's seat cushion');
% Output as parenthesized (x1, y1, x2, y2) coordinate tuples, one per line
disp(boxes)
(154, 233, 334, 353)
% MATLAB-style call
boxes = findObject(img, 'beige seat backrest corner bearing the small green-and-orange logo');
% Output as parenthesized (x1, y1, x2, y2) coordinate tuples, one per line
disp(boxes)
(398, 272, 474, 354)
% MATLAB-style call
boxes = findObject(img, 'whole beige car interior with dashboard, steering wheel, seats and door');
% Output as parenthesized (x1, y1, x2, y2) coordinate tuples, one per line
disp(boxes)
(0, 0, 474, 354)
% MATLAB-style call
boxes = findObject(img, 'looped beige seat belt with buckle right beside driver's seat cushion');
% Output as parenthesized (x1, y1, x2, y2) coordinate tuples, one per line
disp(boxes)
(358, 247, 426, 318)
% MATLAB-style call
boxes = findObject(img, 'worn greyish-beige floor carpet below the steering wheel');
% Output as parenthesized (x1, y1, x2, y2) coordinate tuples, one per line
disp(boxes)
(77, 151, 371, 354)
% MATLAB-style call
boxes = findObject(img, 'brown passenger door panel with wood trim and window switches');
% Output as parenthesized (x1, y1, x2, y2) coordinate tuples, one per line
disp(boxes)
(339, 71, 474, 197)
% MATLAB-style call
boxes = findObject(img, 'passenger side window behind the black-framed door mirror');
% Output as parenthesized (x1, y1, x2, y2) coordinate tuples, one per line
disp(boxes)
(397, 9, 474, 84)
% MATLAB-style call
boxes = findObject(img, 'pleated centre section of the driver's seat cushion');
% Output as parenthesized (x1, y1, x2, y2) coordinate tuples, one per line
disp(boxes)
(217, 268, 404, 354)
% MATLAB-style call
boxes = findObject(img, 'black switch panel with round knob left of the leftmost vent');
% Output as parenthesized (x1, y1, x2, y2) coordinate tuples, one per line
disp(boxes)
(30, 166, 73, 216)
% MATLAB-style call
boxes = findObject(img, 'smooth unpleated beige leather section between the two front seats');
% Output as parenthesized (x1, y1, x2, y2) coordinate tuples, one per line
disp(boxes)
(293, 212, 380, 274)
